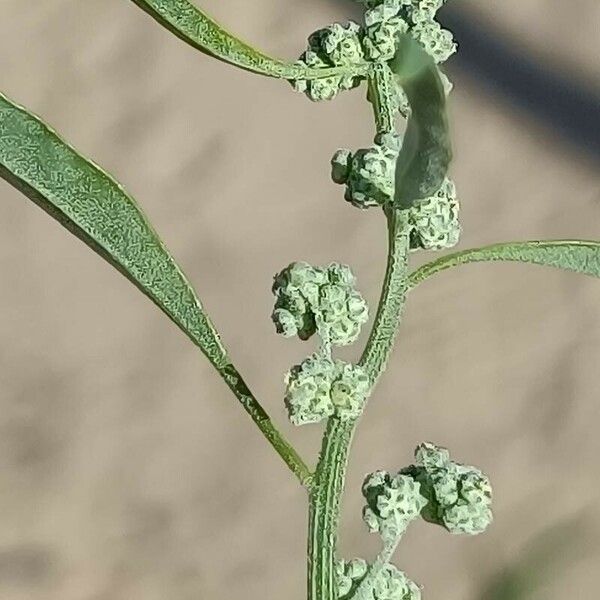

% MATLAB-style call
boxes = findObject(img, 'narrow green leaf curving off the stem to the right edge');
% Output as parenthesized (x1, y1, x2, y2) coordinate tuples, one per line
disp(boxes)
(409, 240, 600, 288)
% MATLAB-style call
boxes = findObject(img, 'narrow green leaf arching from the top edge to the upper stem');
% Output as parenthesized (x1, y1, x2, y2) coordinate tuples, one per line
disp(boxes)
(132, 0, 367, 79)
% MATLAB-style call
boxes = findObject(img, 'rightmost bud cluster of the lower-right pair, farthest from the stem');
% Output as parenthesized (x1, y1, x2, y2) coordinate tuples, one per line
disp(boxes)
(401, 443, 493, 535)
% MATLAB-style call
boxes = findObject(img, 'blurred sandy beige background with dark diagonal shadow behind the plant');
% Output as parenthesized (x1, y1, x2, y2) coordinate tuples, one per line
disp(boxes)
(0, 0, 600, 600)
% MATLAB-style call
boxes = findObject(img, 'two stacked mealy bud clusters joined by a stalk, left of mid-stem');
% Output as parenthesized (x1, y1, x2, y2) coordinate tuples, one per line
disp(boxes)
(272, 262, 371, 425)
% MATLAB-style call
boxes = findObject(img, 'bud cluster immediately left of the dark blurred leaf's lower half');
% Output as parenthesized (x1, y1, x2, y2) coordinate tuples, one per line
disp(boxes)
(332, 134, 400, 208)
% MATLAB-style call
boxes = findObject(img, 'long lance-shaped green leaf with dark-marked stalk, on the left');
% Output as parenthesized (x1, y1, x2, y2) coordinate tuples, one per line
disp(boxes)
(0, 94, 308, 488)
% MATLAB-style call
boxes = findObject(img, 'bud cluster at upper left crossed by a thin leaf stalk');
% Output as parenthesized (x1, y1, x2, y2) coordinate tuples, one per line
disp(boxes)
(293, 21, 364, 102)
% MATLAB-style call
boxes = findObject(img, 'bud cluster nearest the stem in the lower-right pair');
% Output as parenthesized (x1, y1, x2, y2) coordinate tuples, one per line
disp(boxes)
(362, 471, 427, 542)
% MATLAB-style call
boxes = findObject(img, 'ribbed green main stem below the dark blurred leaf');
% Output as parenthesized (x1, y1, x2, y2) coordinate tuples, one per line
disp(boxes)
(308, 209, 409, 600)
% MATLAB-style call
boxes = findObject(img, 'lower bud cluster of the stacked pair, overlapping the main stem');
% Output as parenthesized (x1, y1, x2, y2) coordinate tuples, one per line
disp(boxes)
(285, 354, 371, 425)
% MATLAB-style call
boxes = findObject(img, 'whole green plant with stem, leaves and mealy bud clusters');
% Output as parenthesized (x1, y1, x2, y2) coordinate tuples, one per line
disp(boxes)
(0, 0, 600, 600)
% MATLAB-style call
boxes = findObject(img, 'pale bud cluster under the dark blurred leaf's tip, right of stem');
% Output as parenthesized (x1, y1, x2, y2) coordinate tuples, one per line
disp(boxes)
(409, 178, 460, 250)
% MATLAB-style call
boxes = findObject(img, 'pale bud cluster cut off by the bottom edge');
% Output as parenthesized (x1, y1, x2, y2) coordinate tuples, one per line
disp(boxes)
(336, 558, 421, 600)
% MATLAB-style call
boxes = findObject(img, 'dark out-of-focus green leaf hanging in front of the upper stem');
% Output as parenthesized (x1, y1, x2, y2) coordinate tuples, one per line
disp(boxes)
(389, 34, 452, 208)
